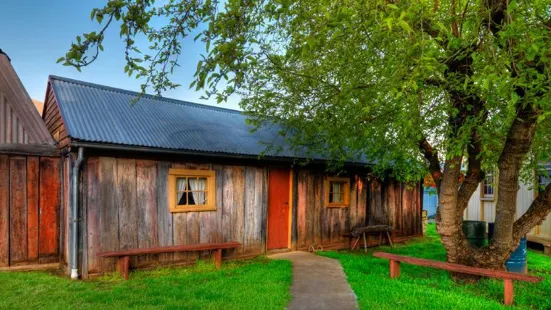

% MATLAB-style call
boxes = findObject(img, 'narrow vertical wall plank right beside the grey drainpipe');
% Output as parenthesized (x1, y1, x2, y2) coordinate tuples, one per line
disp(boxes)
(85, 157, 103, 273)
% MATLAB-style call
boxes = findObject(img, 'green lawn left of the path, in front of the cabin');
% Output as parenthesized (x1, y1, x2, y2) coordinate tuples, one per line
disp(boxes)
(0, 258, 291, 310)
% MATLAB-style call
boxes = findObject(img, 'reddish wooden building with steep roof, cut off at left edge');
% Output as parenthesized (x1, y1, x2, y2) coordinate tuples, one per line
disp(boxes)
(0, 50, 62, 270)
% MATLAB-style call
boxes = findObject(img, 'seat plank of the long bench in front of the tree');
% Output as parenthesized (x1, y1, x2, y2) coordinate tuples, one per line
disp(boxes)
(373, 252, 542, 283)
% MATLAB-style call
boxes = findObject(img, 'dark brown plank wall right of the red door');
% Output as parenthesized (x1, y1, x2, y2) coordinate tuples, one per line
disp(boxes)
(296, 170, 422, 250)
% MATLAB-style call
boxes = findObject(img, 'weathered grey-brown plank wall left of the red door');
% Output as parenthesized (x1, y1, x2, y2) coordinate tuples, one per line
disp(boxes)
(81, 157, 268, 277)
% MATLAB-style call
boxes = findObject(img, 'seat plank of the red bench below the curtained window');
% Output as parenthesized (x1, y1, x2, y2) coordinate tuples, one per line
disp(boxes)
(97, 241, 241, 257)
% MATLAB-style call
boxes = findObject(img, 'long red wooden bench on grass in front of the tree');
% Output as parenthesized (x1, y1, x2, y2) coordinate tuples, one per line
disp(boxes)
(373, 252, 543, 306)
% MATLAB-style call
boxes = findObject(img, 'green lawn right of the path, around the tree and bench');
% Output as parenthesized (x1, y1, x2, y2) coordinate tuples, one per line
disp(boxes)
(321, 225, 551, 310)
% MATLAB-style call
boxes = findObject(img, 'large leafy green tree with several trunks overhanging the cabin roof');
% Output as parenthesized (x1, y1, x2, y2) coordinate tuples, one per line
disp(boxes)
(64, 0, 551, 264)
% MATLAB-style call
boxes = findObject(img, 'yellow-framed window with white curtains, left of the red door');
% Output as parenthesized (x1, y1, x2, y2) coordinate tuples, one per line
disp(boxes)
(168, 169, 216, 212)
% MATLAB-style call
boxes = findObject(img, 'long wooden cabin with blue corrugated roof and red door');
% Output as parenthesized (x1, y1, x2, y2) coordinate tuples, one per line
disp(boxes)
(43, 76, 422, 278)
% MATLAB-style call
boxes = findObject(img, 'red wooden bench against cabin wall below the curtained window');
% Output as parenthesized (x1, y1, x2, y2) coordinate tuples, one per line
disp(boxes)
(98, 241, 241, 280)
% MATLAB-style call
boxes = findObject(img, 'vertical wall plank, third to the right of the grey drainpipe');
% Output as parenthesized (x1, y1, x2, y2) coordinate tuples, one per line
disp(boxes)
(115, 159, 139, 266)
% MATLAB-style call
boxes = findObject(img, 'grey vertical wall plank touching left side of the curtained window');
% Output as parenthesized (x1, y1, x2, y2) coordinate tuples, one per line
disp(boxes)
(156, 162, 174, 263)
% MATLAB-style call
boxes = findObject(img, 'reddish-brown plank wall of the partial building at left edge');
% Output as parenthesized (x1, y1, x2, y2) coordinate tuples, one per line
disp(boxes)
(0, 154, 62, 267)
